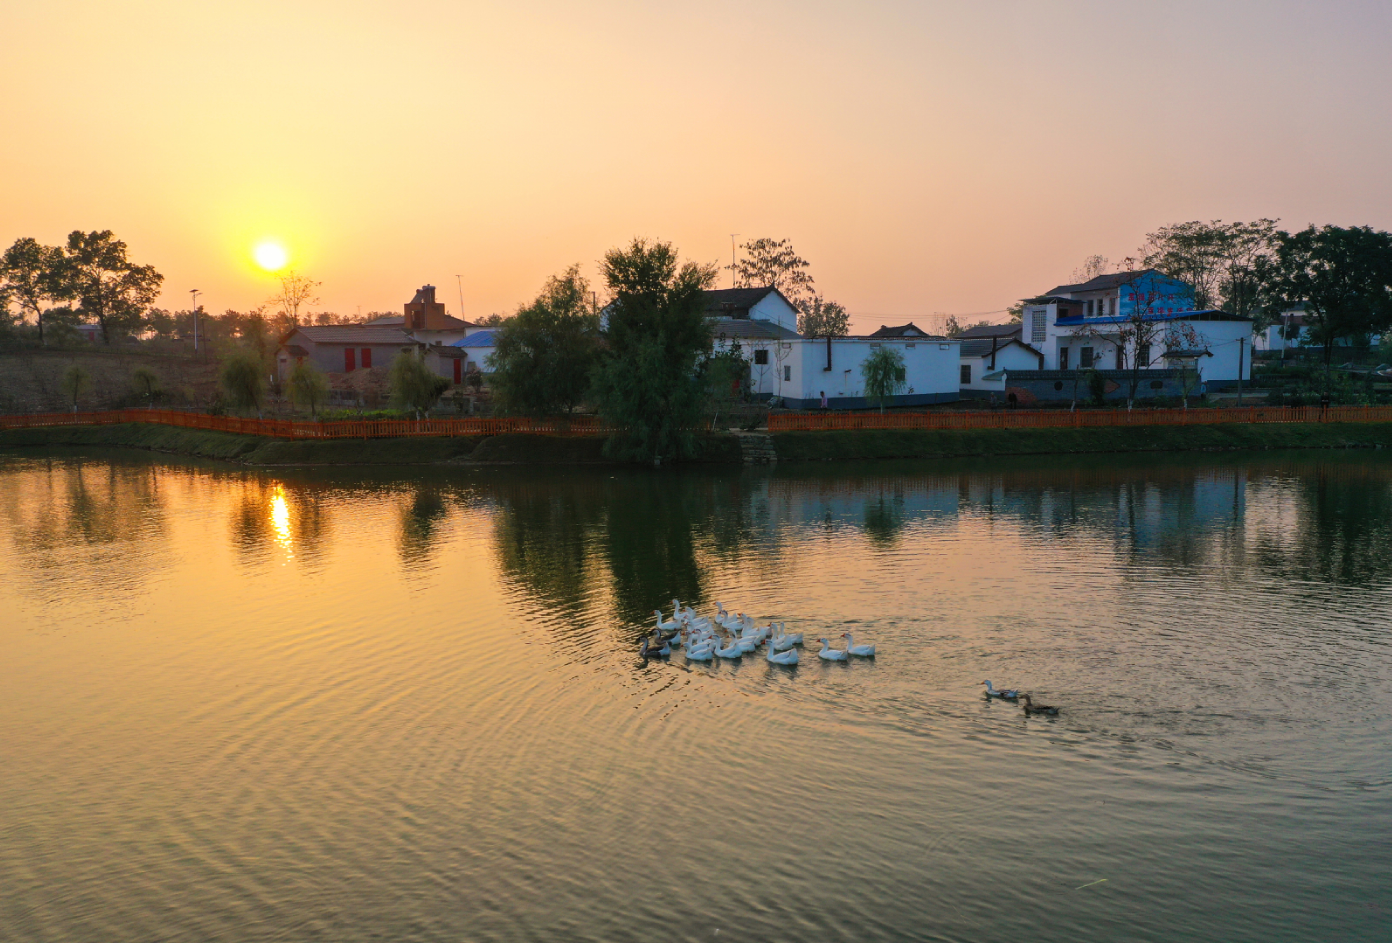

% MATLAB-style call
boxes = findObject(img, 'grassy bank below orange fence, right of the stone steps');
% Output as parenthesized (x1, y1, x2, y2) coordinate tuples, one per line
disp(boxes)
(773, 422, 1392, 461)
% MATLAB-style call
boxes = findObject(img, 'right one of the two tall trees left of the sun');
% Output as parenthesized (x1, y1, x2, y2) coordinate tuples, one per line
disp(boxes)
(61, 230, 164, 345)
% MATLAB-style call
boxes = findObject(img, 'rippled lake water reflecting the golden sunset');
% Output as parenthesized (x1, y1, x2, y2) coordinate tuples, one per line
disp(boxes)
(0, 453, 1392, 943)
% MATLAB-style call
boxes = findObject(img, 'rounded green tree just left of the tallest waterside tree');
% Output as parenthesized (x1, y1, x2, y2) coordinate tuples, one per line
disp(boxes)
(491, 265, 600, 415)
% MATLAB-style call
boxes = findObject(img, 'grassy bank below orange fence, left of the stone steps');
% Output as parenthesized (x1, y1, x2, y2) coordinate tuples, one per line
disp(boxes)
(0, 422, 739, 465)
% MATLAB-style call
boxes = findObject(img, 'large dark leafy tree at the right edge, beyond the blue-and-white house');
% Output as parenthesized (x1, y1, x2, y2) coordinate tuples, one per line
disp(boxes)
(1258, 226, 1392, 390)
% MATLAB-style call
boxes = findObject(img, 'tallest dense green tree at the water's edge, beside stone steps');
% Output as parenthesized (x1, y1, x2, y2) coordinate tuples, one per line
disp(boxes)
(593, 240, 715, 462)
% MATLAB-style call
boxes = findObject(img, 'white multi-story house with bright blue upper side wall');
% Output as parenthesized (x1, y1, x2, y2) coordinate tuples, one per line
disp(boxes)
(1022, 269, 1251, 390)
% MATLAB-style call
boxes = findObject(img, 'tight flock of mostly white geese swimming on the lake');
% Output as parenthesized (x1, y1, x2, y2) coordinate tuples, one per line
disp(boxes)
(638, 599, 874, 664)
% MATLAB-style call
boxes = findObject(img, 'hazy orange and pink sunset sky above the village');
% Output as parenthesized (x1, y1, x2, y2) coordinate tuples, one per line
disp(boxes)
(0, 0, 1392, 330)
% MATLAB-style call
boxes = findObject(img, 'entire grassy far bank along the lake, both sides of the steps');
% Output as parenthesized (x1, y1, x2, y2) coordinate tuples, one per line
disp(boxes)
(0, 422, 1392, 465)
